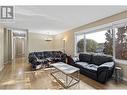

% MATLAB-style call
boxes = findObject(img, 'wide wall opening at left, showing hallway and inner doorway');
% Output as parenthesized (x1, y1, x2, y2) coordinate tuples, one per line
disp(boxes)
(4, 28, 28, 63)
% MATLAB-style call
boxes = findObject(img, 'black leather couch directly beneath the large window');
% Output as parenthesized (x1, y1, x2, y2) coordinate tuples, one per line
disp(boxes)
(68, 53, 115, 83)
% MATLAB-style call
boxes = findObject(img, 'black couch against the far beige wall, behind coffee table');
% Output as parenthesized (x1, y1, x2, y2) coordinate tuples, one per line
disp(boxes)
(28, 51, 67, 70)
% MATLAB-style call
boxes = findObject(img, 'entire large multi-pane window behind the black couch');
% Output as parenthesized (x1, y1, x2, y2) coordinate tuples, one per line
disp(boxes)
(76, 24, 127, 60)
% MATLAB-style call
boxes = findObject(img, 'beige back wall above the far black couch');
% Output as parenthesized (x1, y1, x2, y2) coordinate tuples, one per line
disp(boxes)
(28, 32, 54, 52)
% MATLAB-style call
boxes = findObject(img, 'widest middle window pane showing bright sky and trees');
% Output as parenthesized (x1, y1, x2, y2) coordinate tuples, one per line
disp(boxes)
(86, 30, 113, 55)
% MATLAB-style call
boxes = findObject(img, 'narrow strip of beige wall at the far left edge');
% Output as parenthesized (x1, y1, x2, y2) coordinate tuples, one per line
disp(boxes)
(0, 24, 4, 70)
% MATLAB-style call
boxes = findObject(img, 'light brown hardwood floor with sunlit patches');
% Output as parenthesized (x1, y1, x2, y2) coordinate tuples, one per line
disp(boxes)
(0, 58, 127, 90)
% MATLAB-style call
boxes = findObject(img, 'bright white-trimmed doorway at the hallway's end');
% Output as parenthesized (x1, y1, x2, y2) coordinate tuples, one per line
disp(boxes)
(12, 30, 28, 60)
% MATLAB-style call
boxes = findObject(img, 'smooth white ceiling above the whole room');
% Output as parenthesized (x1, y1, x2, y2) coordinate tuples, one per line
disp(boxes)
(4, 6, 127, 35)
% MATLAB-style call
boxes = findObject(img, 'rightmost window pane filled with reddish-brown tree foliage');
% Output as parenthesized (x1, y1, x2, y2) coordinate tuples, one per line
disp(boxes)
(115, 27, 127, 60)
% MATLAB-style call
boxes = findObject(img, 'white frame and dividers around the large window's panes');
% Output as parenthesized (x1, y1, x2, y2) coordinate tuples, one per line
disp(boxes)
(74, 19, 127, 65)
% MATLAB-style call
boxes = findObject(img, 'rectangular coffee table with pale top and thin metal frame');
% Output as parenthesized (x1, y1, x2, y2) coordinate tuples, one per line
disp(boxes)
(50, 62, 80, 89)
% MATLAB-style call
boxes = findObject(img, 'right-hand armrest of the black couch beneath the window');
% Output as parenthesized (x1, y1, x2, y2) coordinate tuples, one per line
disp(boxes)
(97, 62, 114, 83)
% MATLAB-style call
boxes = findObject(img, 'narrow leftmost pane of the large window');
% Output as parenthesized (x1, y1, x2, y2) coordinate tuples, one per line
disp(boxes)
(76, 34, 84, 53)
